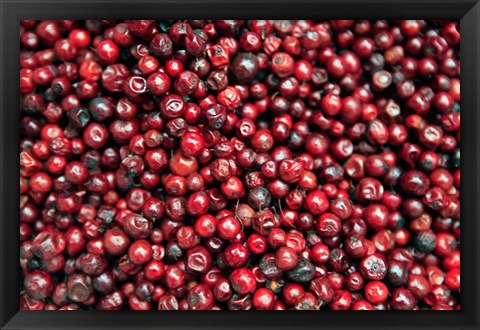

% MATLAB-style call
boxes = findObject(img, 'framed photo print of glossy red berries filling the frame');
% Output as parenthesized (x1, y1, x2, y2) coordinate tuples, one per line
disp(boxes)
(19, 19, 461, 311)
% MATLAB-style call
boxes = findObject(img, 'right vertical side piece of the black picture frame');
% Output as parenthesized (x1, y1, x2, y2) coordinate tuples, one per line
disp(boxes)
(460, 2, 480, 329)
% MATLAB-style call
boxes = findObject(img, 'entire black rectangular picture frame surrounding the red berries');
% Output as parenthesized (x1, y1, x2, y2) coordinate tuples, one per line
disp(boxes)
(0, 0, 480, 330)
